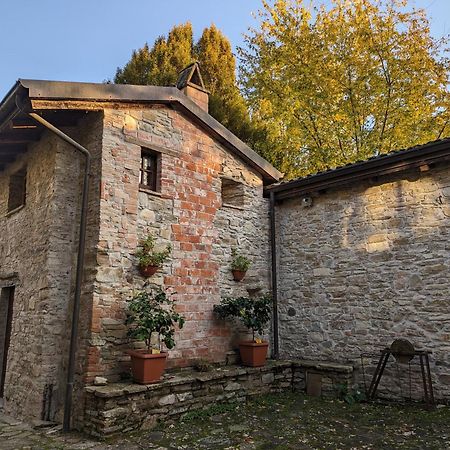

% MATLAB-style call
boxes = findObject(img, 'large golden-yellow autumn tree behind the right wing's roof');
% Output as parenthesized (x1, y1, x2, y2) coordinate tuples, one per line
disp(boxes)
(240, 0, 450, 177)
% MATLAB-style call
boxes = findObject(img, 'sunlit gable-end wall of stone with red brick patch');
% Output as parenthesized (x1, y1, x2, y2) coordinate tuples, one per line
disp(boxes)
(87, 105, 269, 380)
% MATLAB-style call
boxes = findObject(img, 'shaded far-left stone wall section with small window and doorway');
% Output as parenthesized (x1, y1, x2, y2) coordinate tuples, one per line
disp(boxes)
(0, 135, 60, 417)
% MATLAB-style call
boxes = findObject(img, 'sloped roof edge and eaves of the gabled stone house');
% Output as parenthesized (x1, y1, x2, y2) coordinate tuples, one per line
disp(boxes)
(0, 79, 282, 184)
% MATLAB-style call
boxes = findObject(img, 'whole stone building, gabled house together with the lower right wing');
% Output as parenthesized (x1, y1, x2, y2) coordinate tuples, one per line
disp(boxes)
(0, 66, 450, 430)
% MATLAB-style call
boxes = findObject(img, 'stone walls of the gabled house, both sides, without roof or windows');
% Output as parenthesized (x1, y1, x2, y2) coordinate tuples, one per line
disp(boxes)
(0, 96, 270, 424)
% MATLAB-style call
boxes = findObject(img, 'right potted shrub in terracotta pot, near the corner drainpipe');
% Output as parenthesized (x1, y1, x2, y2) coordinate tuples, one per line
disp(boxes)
(214, 295, 272, 367)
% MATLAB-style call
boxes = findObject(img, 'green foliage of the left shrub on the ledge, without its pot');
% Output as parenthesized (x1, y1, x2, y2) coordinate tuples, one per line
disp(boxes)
(125, 289, 185, 352)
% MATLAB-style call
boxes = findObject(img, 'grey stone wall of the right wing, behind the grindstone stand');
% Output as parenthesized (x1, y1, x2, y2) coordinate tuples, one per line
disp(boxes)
(277, 167, 450, 400)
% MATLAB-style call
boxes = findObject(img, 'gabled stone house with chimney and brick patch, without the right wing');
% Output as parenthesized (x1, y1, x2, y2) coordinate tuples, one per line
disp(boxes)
(0, 66, 281, 426)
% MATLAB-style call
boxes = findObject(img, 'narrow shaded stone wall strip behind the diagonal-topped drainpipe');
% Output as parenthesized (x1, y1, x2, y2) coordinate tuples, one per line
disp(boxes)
(53, 112, 103, 423)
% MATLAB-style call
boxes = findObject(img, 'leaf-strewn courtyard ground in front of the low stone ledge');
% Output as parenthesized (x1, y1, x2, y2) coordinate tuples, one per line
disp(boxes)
(0, 393, 450, 450)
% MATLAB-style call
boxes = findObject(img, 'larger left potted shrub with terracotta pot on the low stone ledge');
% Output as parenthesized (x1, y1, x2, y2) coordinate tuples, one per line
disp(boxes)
(125, 289, 184, 384)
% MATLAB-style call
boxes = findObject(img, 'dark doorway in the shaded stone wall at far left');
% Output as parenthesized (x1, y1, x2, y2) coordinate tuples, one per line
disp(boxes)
(0, 286, 14, 399)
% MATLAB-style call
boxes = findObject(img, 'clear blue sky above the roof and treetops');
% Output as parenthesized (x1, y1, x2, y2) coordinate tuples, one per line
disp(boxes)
(0, 0, 450, 98)
